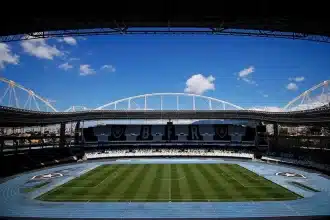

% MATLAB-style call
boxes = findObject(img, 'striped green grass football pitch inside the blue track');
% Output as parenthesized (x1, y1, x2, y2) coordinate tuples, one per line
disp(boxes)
(38, 164, 299, 202)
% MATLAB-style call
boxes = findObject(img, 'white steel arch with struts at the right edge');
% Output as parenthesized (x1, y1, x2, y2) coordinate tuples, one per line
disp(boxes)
(283, 80, 330, 111)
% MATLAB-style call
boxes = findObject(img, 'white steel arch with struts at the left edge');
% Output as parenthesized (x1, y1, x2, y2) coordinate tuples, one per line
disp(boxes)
(0, 77, 57, 112)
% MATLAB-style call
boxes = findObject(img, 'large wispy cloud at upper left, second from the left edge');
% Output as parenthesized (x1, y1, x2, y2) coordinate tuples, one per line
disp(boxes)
(21, 39, 63, 60)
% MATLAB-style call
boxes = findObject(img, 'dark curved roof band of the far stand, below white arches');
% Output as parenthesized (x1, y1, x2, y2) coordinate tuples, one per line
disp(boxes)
(0, 107, 330, 127)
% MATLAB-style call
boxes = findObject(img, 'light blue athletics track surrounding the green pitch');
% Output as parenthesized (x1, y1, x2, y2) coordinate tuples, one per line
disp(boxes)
(0, 159, 330, 219)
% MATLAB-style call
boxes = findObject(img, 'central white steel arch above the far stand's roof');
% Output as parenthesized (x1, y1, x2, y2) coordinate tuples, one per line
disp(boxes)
(95, 93, 243, 110)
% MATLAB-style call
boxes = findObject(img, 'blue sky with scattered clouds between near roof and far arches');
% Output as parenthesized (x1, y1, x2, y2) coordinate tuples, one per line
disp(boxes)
(0, 35, 330, 110)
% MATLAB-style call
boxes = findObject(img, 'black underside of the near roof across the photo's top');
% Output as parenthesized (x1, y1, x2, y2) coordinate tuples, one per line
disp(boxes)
(0, 0, 330, 41)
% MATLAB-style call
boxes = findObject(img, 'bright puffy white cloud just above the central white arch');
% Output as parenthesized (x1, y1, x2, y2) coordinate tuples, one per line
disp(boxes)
(184, 74, 215, 95)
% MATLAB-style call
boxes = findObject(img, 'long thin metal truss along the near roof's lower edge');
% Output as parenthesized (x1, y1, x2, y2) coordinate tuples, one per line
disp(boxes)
(0, 27, 330, 43)
